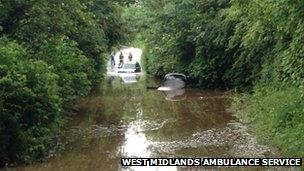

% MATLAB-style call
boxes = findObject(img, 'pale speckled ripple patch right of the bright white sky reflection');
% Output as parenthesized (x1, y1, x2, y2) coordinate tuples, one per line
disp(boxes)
(152, 122, 272, 157)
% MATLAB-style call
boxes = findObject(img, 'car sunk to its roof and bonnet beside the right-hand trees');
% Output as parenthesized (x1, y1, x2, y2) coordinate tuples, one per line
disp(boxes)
(158, 73, 187, 91)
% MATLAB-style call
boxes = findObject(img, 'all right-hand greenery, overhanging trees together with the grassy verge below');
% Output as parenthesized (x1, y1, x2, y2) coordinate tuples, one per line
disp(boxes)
(123, 0, 304, 157)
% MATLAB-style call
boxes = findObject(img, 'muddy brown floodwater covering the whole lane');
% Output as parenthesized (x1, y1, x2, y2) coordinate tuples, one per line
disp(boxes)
(6, 76, 282, 171)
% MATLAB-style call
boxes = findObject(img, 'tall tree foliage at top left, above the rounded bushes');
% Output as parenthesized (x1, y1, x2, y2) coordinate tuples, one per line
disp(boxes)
(0, 0, 126, 83)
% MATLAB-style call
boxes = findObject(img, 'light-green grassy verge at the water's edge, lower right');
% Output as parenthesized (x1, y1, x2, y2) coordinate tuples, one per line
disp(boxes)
(232, 86, 304, 157)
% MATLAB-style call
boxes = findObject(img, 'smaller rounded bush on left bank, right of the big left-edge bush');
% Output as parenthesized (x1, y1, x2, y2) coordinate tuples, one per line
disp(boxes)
(34, 40, 94, 104)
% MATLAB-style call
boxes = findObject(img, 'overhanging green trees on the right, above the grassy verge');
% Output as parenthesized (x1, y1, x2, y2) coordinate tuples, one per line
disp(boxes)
(124, 0, 303, 88)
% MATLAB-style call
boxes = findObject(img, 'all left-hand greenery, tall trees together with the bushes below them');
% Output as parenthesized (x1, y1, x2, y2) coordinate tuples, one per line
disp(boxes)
(0, 0, 128, 166)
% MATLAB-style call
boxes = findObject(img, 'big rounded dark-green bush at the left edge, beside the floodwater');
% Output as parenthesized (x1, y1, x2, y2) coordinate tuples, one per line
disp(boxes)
(0, 38, 62, 165)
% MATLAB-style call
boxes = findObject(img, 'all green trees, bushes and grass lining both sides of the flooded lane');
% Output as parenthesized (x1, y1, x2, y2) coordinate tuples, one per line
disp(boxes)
(0, 0, 304, 167)
